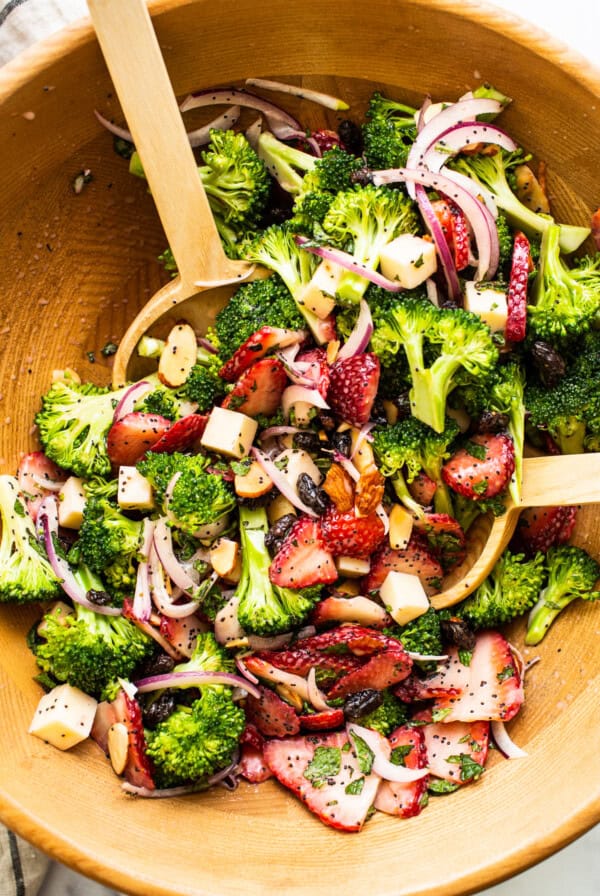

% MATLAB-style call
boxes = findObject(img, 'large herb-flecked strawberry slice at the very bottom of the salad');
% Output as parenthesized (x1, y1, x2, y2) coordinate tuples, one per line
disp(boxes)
(264, 731, 380, 832)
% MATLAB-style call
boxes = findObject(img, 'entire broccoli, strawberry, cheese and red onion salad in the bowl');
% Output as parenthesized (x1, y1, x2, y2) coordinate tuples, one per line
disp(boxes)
(0, 81, 600, 831)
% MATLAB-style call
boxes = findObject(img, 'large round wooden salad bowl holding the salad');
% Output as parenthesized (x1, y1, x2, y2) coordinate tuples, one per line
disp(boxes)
(0, 0, 600, 896)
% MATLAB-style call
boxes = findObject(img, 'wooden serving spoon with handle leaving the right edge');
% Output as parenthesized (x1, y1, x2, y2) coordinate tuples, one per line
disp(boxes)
(431, 453, 600, 610)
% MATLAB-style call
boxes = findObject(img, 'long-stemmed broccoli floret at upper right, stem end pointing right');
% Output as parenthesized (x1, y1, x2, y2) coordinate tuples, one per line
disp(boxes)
(449, 150, 590, 252)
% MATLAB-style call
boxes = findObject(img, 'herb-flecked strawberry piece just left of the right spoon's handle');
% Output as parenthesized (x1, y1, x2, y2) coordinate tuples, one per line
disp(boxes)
(442, 433, 515, 501)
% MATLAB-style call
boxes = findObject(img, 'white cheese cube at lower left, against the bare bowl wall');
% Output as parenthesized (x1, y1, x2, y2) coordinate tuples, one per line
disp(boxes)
(29, 684, 98, 750)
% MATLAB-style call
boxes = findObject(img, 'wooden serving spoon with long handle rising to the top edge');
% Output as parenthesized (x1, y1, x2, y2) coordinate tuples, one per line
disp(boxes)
(88, 0, 255, 386)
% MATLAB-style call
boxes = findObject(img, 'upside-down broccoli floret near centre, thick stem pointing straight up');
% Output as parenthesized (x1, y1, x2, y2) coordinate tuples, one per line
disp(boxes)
(235, 506, 321, 636)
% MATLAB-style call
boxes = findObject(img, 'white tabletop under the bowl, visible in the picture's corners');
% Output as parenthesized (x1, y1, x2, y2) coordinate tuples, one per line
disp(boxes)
(10, 0, 600, 896)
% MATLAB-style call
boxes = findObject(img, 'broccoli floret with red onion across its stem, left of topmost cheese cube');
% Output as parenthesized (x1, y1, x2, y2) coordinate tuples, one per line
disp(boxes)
(323, 184, 418, 303)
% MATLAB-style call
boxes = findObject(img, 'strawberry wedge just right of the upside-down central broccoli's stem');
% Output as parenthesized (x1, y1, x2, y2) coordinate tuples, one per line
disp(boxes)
(269, 516, 338, 589)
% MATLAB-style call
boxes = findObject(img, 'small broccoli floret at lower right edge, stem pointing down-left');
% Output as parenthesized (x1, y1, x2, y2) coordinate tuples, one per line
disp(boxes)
(525, 544, 600, 645)
